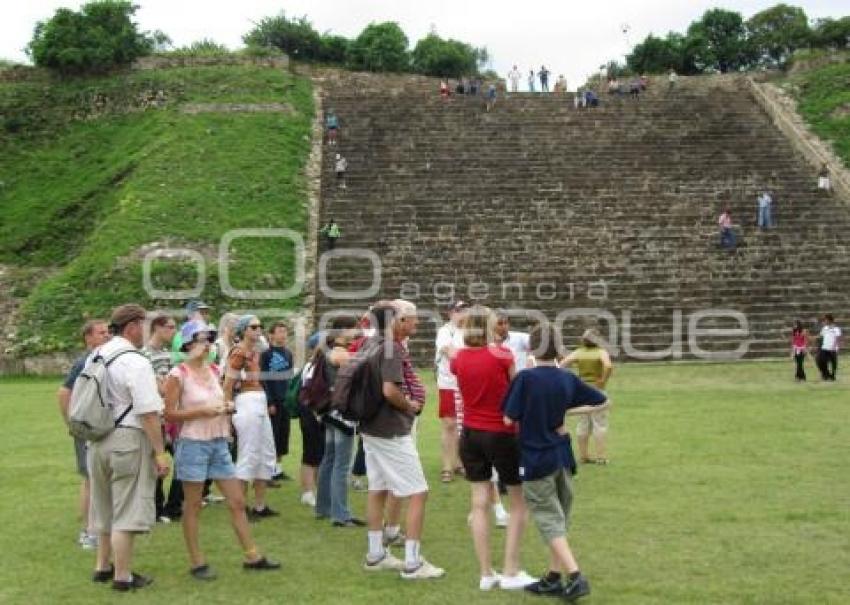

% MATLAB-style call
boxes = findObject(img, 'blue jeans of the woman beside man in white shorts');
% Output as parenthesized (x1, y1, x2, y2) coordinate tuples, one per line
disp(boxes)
(316, 424, 354, 521)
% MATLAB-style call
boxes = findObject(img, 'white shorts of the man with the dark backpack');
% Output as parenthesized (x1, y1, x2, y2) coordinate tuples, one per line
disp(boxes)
(363, 435, 428, 498)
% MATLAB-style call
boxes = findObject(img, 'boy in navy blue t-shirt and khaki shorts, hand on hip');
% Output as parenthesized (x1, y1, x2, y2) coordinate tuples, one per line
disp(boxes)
(504, 324, 610, 601)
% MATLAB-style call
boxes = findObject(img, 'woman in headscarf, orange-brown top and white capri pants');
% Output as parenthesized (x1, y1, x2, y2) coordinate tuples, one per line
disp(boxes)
(223, 315, 279, 520)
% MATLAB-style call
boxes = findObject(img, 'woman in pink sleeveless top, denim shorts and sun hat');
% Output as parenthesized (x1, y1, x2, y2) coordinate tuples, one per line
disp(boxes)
(164, 320, 280, 580)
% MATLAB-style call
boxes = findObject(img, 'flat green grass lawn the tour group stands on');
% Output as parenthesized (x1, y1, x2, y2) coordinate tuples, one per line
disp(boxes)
(0, 362, 850, 605)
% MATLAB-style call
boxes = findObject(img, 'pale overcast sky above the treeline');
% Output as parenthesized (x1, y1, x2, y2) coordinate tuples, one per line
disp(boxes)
(0, 0, 850, 88)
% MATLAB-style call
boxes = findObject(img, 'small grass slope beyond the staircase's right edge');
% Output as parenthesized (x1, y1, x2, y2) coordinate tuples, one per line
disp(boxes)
(791, 57, 850, 166)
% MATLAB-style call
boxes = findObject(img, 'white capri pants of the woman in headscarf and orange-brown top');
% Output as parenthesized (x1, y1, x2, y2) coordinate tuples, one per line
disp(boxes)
(233, 391, 277, 481)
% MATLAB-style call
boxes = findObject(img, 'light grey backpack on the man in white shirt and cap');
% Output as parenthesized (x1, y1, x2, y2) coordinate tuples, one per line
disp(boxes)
(68, 348, 144, 441)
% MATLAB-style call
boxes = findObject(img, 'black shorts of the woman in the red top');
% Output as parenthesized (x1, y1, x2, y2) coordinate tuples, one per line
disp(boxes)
(460, 427, 521, 485)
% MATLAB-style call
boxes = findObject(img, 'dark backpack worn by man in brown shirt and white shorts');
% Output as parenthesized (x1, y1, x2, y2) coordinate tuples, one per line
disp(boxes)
(332, 340, 384, 422)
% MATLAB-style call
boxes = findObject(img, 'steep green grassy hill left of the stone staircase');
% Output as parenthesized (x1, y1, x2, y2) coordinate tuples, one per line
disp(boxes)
(0, 66, 313, 354)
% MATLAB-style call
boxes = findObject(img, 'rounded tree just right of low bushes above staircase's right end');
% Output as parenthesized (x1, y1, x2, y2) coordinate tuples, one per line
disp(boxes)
(685, 8, 748, 73)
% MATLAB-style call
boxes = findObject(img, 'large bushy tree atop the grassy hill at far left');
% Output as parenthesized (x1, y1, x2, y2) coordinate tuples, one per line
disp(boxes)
(27, 0, 155, 74)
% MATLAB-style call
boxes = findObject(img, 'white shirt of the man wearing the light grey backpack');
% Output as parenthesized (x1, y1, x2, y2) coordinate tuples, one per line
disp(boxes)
(99, 336, 163, 429)
